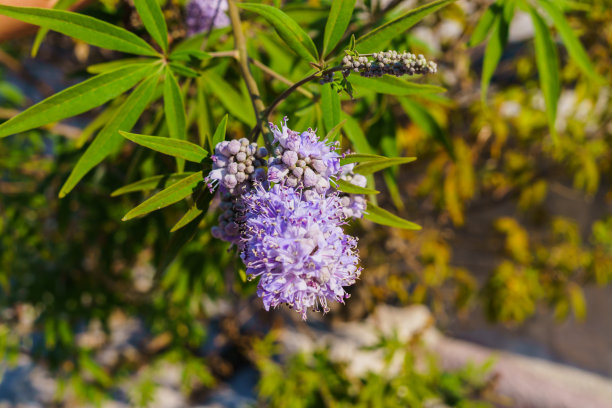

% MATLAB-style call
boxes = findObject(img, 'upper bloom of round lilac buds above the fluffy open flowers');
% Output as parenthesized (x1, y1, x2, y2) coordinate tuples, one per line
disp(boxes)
(268, 118, 340, 194)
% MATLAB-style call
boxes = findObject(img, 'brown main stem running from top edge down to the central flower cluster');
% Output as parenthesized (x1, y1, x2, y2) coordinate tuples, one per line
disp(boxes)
(227, 0, 266, 140)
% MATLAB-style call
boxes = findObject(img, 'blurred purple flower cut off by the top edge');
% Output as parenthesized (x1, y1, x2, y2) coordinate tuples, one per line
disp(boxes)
(185, 0, 230, 35)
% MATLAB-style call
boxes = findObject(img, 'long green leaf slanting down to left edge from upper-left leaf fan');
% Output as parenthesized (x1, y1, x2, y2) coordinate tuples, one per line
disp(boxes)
(0, 64, 157, 138)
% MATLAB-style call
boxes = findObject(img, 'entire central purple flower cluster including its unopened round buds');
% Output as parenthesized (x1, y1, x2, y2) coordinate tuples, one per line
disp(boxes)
(207, 118, 365, 319)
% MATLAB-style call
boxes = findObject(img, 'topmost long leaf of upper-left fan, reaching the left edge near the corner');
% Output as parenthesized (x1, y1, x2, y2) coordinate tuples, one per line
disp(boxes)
(0, 5, 159, 56)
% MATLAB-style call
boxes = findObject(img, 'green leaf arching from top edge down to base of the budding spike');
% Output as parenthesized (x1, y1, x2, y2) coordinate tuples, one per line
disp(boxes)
(238, 3, 319, 62)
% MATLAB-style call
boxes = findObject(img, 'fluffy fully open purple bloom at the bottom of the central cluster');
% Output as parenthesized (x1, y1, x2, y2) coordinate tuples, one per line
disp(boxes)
(241, 184, 361, 319)
